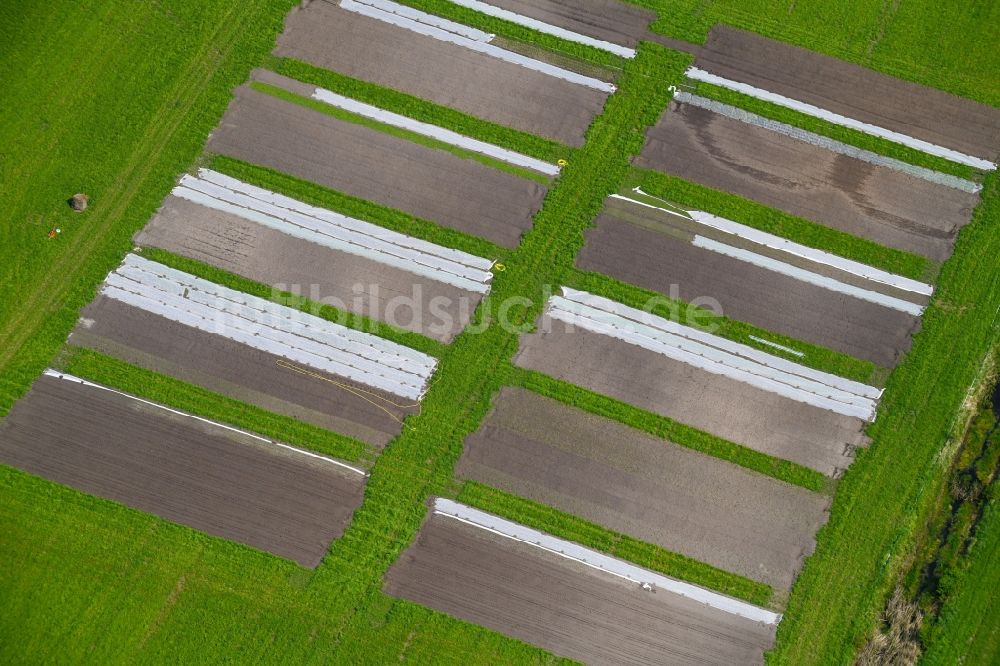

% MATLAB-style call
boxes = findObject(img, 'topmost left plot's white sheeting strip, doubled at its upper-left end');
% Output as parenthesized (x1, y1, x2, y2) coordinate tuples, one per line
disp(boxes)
(340, 0, 615, 94)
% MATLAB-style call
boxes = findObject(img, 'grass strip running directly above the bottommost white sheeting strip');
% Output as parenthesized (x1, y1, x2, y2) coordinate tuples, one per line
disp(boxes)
(456, 481, 773, 607)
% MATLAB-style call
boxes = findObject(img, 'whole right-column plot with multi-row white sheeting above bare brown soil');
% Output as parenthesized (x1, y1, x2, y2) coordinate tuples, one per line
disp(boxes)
(514, 288, 880, 475)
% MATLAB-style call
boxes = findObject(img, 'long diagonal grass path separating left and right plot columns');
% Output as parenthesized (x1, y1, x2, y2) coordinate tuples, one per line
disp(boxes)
(300, 44, 691, 661)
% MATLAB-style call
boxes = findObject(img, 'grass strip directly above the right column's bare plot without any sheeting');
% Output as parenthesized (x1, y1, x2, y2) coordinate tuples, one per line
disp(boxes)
(506, 366, 824, 493)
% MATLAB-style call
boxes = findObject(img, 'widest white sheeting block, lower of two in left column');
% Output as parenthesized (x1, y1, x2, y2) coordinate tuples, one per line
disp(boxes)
(101, 254, 437, 400)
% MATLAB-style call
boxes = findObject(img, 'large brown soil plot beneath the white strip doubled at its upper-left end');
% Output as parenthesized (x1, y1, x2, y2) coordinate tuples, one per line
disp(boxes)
(275, 2, 607, 146)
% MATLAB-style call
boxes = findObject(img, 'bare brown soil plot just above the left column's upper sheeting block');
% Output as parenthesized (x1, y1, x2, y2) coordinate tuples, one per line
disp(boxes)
(208, 87, 545, 247)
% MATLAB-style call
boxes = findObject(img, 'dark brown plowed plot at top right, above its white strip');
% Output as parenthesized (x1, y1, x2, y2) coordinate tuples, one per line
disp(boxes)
(695, 25, 1000, 161)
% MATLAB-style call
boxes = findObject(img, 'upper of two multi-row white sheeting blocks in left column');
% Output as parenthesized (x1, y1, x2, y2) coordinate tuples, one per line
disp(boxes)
(172, 169, 493, 294)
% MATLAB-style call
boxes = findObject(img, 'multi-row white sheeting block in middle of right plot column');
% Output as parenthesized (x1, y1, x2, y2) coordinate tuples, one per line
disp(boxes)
(547, 287, 880, 420)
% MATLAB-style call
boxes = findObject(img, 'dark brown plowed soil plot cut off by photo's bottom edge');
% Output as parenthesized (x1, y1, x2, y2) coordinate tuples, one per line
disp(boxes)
(386, 508, 773, 666)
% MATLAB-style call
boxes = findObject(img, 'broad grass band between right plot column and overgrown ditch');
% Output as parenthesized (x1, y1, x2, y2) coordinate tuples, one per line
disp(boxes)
(768, 173, 1000, 665)
